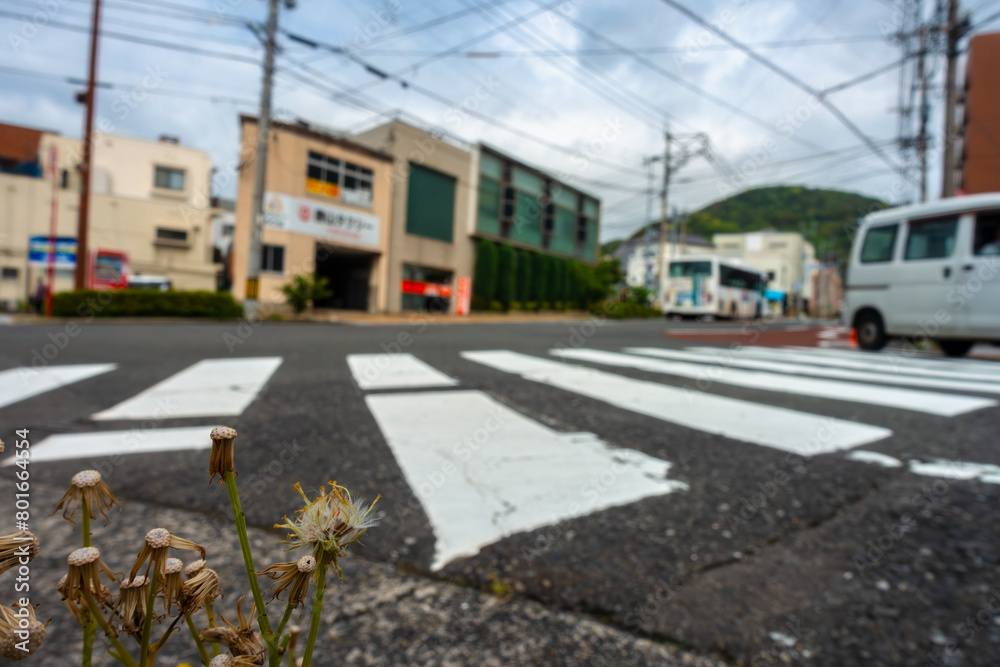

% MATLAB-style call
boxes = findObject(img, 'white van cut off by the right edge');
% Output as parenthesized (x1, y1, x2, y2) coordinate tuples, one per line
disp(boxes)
(843, 193, 1000, 356)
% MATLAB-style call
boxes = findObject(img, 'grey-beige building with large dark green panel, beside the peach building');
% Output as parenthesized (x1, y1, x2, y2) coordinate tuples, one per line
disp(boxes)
(353, 120, 475, 313)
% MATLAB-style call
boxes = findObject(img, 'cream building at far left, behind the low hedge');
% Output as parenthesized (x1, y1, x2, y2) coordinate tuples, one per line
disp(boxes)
(0, 124, 219, 308)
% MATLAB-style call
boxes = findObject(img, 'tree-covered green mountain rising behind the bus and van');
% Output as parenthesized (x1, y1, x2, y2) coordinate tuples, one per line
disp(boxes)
(631, 185, 887, 265)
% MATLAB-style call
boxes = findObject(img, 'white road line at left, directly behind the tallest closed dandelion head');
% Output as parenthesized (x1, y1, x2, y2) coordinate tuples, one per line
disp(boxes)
(4, 426, 214, 465)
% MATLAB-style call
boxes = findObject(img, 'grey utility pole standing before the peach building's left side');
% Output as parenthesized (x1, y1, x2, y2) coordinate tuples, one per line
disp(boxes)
(243, 0, 278, 317)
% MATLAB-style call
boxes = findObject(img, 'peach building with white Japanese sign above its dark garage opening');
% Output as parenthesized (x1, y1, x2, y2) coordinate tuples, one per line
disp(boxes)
(232, 116, 392, 313)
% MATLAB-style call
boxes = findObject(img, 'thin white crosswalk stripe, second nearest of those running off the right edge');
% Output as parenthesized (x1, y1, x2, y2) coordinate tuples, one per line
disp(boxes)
(625, 347, 1000, 394)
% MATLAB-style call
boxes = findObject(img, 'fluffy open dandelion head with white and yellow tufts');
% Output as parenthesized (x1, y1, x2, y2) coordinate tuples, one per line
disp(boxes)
(275, 482, 381, 578)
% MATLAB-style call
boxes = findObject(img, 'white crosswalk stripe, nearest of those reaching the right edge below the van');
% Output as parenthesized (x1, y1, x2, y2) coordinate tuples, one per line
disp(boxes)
(550, 348, 997, 417)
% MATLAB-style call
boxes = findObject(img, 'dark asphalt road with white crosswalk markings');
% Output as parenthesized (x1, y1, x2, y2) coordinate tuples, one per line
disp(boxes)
(0, 320, 1000, 665)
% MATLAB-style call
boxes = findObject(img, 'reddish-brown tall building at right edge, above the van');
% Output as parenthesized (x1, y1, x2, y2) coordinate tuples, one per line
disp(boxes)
(955, 32, 1000, 195)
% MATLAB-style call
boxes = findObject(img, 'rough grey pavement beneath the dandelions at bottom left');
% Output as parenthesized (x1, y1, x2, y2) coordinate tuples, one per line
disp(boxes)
(15, 480, 725, 667)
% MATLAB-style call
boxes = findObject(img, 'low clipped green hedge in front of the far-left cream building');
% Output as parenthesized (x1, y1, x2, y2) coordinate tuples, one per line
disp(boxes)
(52, 289, 243, 319)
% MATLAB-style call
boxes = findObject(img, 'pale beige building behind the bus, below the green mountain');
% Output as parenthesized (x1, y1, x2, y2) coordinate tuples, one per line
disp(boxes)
(712, 231, 816, 302)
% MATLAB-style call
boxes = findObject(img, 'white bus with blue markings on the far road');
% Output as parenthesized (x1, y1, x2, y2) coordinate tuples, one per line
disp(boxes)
(663, 255, 767, 320)
